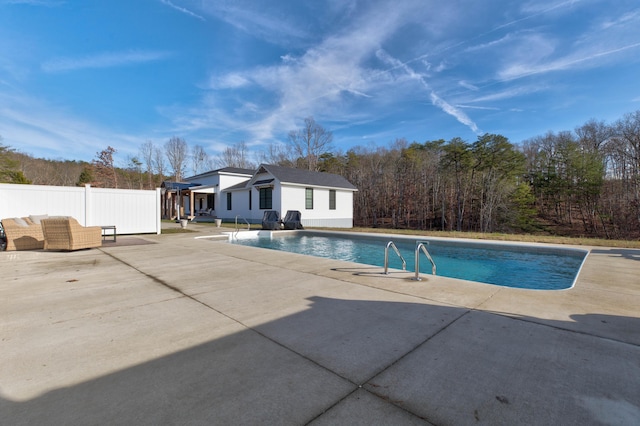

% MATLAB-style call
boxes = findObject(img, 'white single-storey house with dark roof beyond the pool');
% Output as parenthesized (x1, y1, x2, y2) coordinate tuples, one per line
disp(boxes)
(162, 164, 357, 228)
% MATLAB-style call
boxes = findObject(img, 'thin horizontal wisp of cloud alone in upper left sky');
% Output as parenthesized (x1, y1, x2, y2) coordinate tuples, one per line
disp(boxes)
(42, 51, 170, 72)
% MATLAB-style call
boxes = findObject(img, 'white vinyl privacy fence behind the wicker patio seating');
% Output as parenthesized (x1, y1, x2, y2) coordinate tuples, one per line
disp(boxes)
(0, 183, 161, 234)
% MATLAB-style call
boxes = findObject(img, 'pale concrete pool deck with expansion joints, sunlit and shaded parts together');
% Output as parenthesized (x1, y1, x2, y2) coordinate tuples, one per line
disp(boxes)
(0, 224, 640, 425)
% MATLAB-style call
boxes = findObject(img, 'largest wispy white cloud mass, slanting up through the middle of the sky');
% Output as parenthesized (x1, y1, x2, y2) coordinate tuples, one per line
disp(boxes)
(182, 0, 420, 140)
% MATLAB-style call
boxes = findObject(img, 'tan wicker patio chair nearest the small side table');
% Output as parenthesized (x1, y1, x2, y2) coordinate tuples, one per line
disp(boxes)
(41, 217, 102, 251)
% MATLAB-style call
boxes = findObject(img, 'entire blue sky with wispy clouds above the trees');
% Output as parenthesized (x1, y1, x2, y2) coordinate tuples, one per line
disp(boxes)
(0, 0, 640, 161)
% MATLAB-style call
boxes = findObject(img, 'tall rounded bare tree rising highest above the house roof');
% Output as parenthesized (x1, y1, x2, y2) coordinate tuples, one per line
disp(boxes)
(288, 117, 333, 171)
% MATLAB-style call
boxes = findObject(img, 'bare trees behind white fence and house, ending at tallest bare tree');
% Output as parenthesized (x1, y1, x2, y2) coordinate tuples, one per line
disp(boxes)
(0, 117, 333, 189)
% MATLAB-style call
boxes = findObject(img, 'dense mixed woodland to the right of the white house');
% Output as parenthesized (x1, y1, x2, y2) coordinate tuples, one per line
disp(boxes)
(328, 111, 640, 239)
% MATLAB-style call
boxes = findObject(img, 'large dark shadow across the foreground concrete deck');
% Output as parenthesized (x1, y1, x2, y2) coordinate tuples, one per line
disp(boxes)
(0, 297, 640, 425)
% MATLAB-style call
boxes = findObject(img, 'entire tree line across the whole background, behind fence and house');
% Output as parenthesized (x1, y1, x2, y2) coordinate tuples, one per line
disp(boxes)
(0, 111, 640, 239)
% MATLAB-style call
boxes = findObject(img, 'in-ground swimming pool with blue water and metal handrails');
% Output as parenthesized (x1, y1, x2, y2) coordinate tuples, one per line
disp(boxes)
(230, 231, 588, 290)
